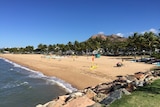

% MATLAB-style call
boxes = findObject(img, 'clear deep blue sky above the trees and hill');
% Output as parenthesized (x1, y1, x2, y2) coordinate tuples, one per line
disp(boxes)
(0, 0, 160, 48)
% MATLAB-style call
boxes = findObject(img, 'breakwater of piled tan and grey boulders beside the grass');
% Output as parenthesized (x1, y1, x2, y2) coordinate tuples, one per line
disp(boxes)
(36, 69, 160, 107)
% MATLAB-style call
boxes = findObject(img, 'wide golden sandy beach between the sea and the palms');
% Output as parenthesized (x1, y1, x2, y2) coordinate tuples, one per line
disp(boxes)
(0, 54, 154, 89)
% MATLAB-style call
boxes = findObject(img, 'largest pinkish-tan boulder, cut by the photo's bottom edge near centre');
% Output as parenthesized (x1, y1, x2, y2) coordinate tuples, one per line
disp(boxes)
(63, 95, 95, 107)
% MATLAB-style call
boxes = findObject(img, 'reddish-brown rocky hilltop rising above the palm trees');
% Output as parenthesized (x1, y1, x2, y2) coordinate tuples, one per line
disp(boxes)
(90, 34, 127, 42)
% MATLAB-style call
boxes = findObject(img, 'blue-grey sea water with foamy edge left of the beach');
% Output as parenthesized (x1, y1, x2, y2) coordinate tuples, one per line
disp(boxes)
(0, 58, 76, 107)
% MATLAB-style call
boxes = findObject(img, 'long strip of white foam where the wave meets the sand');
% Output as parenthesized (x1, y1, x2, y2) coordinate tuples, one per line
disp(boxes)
(0, 58, 77, 93)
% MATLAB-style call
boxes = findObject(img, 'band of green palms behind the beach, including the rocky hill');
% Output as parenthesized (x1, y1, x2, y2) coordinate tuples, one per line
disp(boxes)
(0, 32, 160, 58)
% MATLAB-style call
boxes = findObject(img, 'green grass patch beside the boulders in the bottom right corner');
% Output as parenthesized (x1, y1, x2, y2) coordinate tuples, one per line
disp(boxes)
(109, 79, 160, 107)
